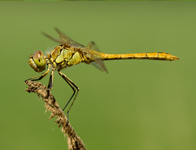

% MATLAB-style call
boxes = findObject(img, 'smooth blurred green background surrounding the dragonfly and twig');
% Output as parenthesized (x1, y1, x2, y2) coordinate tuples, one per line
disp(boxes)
(0, 2, 196, 150)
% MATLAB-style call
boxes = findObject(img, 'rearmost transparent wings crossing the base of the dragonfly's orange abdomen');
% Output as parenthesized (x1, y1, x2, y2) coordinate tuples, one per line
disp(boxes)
(84, 41, 108, 73)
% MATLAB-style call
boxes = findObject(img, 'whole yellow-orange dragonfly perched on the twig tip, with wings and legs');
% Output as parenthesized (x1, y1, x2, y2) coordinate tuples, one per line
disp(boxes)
(25, 28, 179, 120)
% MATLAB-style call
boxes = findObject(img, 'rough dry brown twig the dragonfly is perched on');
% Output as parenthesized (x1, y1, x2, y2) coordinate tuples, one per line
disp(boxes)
(26, 81, 86, 150)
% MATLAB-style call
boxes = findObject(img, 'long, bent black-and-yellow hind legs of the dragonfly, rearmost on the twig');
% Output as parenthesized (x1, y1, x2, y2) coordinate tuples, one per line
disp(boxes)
(58, 70, 79, 122)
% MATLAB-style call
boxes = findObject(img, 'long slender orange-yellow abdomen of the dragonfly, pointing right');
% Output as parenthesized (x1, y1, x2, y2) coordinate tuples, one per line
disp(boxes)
(101, 52, 179, 61)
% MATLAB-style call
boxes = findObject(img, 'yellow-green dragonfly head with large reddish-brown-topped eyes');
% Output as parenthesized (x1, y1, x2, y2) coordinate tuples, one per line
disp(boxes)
(29, 51, 46, 72)
